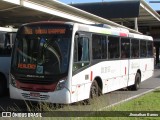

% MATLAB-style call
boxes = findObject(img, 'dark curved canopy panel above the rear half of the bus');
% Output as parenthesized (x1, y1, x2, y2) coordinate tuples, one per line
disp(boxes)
(71, 0, 140, 19)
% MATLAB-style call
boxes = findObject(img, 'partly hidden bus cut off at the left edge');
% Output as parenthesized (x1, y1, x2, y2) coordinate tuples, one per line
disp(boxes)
(0, 27, 17, 96)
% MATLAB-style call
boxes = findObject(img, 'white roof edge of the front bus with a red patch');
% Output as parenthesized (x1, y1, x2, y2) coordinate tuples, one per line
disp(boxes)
(19, 21, 153, 40)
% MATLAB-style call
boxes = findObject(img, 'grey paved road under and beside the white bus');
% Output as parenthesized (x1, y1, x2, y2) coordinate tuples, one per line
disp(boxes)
(0, 69, 160, 111)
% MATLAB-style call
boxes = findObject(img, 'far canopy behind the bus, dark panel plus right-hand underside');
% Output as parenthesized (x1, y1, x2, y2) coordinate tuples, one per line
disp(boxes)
(71, 0, 160, 26)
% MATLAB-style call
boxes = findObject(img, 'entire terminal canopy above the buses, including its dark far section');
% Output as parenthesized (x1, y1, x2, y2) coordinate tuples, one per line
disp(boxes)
(0, 0, 160, 34)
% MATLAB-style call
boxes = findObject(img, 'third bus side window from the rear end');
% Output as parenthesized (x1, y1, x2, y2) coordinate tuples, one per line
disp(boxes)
(131, 39, 139, 58)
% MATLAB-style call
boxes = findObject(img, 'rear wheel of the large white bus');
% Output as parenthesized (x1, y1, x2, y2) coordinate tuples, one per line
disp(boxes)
(132, 73, 141, 91)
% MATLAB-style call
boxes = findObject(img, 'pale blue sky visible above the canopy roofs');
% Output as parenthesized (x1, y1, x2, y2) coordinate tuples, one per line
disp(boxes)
(59, 0, 160, 10)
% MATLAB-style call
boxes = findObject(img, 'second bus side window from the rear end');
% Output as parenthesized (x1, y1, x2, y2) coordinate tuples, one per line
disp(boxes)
(140, 40, 147, 57)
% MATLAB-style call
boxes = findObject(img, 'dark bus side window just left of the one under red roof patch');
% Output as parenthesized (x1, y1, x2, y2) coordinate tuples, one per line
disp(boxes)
(108, 36, 120, 59)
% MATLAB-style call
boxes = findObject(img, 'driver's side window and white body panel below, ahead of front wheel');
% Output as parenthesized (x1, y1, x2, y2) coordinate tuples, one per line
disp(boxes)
(71, 32, 90, 102)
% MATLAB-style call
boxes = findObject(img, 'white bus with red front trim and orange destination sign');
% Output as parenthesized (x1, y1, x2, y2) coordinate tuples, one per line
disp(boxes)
(10, 21, 154, 104)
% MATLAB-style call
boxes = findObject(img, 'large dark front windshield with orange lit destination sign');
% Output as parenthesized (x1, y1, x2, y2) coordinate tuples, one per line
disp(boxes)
(12, 24, 72, 75)
